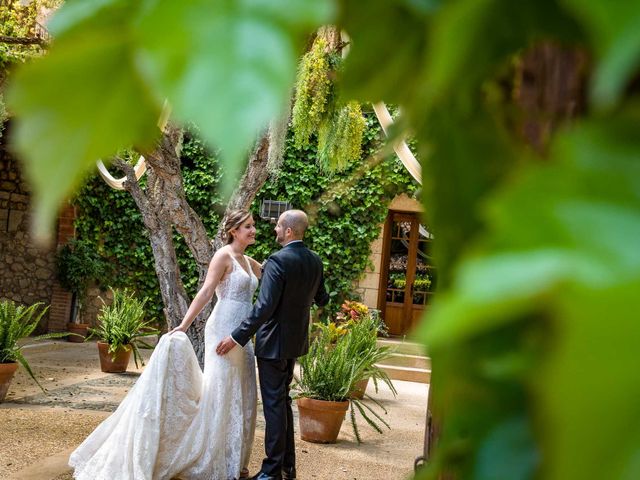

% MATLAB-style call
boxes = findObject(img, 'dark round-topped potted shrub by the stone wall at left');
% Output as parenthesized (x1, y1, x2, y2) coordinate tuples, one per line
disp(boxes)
(56, 239, 106, 342)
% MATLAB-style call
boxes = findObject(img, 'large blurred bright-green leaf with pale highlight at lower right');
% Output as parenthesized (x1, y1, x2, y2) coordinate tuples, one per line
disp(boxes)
(423, 110, 640, 480)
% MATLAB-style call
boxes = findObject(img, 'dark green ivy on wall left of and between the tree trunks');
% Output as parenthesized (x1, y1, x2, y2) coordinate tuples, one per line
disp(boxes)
(74, 131, 224, 318)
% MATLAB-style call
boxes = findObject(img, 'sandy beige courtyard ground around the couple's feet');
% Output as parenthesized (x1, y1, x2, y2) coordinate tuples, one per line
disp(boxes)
(0, 341, 428, 480)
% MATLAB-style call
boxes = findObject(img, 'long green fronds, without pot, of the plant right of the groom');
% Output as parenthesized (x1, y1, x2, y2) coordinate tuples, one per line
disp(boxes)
(296, 317, 396, 443)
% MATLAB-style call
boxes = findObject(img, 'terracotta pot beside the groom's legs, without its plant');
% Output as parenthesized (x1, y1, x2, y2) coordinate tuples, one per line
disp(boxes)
(297, 398, 349, 443)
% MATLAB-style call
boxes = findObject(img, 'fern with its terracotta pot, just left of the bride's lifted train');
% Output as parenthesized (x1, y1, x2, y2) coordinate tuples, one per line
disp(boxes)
(89, 289, 160, 373)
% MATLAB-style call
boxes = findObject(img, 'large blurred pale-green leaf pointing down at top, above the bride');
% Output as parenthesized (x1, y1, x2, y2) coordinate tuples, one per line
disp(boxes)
(139, 0, 332, 195)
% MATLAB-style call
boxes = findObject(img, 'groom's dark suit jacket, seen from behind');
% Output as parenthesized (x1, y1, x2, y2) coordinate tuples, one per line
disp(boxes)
(231, 242, 329, 359)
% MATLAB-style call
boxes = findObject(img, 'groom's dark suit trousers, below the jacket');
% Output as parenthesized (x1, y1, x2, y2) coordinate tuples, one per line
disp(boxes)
(258, 358, 296, 478)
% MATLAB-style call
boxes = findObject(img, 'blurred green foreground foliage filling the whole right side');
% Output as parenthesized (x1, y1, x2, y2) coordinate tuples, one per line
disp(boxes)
(332, 0, 640, 479)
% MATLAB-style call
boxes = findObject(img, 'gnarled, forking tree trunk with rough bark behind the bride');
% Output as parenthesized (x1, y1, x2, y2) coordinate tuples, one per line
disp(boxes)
(115, 125, 269, 366)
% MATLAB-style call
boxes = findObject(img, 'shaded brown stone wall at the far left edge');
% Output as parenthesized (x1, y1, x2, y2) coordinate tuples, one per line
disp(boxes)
(0, 142, 55, 331)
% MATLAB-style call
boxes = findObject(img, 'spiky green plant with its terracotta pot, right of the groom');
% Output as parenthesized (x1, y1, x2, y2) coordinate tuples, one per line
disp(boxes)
(296, 317, 396, 443)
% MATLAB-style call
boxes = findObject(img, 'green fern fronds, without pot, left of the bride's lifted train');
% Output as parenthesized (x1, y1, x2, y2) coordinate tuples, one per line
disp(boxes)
(87, 289, 160, 368)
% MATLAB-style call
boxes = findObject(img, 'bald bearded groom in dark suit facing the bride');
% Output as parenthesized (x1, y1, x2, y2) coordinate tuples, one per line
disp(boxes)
(216, 210, 329, 480)
